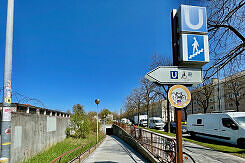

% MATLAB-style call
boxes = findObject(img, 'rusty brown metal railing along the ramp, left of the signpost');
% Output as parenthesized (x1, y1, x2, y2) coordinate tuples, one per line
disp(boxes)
(114, 122, 176, 162)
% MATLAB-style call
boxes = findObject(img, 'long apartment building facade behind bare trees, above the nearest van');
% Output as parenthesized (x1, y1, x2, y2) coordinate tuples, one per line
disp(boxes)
(185, 71, 245, 119)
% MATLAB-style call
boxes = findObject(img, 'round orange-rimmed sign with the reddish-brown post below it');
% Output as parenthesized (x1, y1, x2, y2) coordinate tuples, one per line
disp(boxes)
(168, 85, 191, 163)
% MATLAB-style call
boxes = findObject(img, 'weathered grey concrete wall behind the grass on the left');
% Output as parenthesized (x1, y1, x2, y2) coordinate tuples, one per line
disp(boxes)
(11, 113, 69, 163)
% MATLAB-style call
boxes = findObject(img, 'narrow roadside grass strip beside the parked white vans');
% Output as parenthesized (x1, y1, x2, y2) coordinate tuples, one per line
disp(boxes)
(142, 128, 245, 158)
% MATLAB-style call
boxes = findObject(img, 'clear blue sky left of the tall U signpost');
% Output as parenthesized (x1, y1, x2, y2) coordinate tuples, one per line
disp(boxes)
(0, 0, 205, 112)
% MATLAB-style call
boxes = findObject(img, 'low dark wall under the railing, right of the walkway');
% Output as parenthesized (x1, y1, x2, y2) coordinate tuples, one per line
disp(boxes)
(112, 124, 160, 163)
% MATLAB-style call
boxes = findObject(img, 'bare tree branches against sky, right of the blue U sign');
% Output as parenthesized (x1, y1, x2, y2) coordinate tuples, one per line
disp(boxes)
(205, 0, 245, 78)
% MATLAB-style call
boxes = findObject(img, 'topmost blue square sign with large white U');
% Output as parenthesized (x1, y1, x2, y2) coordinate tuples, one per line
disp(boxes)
(178, 5, 207, 33)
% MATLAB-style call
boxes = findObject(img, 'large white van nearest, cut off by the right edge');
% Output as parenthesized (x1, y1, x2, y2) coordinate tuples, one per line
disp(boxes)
(187, 112, 245, 147)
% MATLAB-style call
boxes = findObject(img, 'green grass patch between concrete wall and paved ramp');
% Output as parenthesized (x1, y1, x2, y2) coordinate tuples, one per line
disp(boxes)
(23, 134, 104, 163)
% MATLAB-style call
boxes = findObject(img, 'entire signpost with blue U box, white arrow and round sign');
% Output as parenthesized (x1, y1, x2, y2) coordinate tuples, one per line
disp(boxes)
(145, 5, 209, 163)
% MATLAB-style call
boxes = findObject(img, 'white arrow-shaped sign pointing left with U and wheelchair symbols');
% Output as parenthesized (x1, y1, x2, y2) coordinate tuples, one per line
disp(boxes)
(145, 66, 202, 84)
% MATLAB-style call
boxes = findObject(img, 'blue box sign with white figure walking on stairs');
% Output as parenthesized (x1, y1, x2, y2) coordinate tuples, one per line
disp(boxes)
(179, 34, 209, 65)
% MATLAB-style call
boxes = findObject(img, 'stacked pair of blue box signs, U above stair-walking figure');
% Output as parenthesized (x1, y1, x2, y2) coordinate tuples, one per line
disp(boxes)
(177, 5, 209, 66)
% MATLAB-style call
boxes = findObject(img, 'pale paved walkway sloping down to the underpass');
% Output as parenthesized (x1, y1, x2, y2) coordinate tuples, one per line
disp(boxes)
(83, 135, 147, 163)
